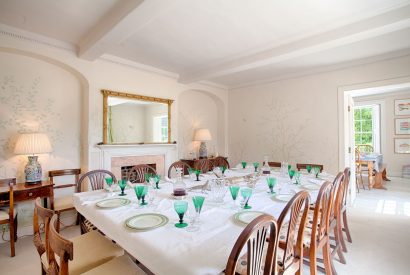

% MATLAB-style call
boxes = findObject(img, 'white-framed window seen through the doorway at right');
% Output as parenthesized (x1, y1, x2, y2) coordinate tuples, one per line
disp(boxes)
(354, 104, 380, 152)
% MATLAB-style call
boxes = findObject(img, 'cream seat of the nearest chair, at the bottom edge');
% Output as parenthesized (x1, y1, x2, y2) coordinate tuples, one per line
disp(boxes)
(83, 255, 146, 275)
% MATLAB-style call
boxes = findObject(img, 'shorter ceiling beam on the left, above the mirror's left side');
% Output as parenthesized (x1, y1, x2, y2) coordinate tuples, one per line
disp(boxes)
(78, 0, 179, 61)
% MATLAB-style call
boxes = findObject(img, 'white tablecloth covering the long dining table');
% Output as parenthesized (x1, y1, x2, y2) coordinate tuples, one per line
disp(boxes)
(74, 171, 332, 275)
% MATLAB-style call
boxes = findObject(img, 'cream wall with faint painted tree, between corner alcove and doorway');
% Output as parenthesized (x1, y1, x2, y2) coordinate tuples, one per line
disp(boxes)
(228, 56, 410, 173)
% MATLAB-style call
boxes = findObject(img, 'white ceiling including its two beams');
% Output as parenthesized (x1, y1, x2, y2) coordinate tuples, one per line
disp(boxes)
(0, 0, 410, 87)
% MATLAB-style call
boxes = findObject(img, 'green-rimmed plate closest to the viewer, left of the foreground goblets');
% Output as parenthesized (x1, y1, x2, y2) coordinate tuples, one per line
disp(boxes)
(125, 213, 168, 231)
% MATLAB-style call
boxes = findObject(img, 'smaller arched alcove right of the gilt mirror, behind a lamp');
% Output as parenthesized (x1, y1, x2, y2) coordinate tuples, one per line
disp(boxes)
(177, 89, 226, 158)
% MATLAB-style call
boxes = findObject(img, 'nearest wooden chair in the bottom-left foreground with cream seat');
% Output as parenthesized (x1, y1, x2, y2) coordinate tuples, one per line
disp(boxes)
(47, 215, 145, 275)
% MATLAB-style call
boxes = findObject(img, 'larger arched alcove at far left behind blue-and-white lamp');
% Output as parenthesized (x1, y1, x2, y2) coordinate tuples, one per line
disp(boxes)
(0, 47, 89, 181)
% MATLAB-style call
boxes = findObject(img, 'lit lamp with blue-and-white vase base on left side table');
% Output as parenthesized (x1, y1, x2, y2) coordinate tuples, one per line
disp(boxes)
(14, 133, 52, 183)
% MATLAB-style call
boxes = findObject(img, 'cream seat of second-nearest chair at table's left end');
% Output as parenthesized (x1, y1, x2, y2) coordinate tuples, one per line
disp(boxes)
(41, 231, 124, 275)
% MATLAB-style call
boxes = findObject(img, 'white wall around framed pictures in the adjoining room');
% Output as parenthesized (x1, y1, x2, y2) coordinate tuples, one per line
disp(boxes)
(354, 91, 410, 176)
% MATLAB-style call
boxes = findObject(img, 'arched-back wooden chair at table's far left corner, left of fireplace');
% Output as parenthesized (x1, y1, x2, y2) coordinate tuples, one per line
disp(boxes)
(77, 170, 117, 234)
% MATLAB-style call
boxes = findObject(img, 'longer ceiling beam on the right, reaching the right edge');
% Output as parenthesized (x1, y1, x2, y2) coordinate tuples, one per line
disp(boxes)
(179, 5, 410, 84)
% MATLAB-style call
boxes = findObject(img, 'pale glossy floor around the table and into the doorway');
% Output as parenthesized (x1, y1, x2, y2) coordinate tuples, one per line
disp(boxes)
(0, 178, 410, 275)
